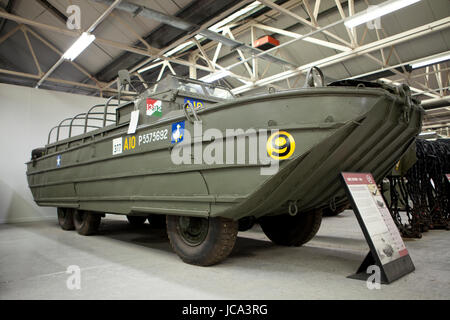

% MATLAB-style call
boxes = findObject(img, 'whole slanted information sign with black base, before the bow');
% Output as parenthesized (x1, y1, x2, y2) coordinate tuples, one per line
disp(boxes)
(342, 173, 415, 283)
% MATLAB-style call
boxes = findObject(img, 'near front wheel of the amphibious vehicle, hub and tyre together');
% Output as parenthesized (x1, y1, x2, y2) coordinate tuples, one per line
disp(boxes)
(166, 216, 238, 266)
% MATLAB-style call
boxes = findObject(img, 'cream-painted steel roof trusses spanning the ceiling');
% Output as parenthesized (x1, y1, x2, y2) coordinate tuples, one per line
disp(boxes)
(0, 0, 450, 131)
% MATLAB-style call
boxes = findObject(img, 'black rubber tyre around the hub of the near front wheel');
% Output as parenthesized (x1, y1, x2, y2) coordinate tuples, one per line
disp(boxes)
(166, 216, 238, 266)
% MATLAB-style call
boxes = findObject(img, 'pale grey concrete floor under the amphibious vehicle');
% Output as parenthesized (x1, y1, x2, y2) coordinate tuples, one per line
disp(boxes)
(0, 211, 450, 299)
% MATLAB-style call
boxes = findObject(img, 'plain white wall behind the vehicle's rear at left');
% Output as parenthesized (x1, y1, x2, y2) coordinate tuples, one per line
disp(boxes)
(0, 83, 112, 223)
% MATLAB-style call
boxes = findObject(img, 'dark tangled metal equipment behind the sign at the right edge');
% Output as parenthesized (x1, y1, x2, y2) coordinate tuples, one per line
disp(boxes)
(383, 139, 450, 238)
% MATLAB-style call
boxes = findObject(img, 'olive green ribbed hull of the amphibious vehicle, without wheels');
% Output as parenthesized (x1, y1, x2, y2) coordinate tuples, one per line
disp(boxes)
(27, 87, 422, 219)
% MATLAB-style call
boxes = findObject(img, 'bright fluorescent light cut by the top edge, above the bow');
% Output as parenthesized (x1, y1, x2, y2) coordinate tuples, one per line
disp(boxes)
(344, 0, 420, 28)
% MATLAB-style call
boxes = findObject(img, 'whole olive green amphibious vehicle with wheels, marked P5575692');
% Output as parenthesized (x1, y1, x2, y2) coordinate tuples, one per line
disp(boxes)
(27, 69, 423, 266)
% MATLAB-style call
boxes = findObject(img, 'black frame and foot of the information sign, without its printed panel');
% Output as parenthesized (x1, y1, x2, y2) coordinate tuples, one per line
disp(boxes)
(341, 173, 415, 284)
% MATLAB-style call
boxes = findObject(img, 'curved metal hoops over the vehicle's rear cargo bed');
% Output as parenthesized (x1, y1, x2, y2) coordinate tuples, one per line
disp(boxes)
(47, 96, 118, 144)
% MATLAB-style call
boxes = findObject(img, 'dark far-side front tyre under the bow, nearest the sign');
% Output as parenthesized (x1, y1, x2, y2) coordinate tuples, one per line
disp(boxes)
(259, 210, 322, 247)
